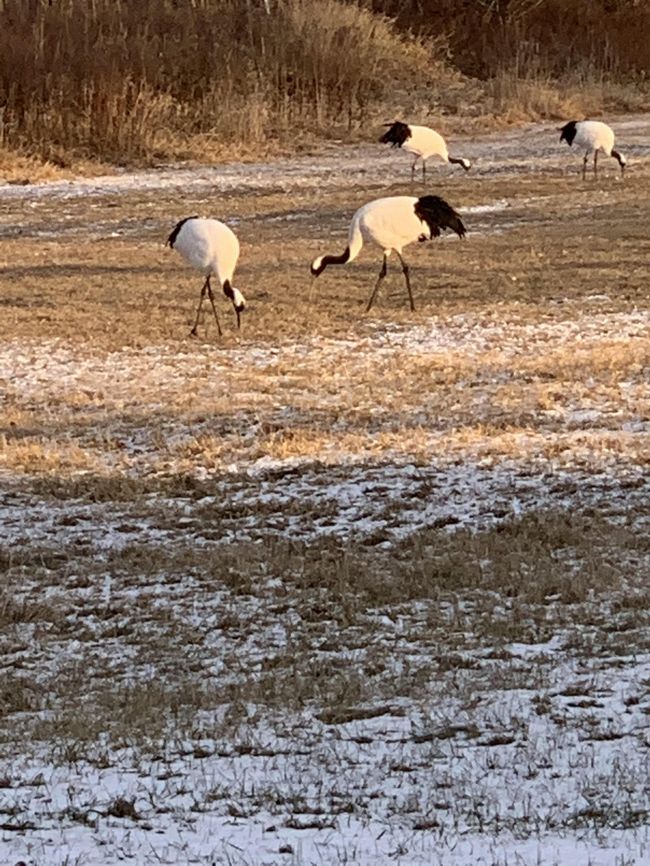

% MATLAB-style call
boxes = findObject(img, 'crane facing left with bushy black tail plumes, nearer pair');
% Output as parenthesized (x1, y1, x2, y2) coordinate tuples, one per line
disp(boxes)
(311, 195, 465, 312)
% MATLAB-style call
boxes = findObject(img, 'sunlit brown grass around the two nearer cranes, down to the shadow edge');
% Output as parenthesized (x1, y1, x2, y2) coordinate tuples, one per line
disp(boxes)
(0, 157, 650, 477)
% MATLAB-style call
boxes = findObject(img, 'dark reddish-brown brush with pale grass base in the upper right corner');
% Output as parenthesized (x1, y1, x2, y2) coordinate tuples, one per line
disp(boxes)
(372, 0, 650, 122)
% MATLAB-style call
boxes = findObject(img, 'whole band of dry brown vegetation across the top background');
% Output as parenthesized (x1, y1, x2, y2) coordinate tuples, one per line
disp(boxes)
(0, 0, 649, 170)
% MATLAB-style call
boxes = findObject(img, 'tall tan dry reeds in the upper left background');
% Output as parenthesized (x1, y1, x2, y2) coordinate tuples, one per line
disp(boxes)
(0, 0, 432, 161)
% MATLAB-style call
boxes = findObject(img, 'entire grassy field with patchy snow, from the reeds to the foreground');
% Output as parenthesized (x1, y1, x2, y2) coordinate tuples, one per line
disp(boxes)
(0, 116, 650, 866)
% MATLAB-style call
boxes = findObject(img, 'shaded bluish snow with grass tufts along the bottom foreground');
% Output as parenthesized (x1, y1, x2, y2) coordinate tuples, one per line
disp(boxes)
(7, 648, 650, 866)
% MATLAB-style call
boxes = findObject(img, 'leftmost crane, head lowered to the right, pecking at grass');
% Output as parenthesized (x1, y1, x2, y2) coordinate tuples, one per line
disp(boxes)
(167, 217, 246, 337)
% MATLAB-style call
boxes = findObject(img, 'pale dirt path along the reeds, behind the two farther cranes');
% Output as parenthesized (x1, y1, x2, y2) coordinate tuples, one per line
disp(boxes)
(0, 114, 650, 201)
